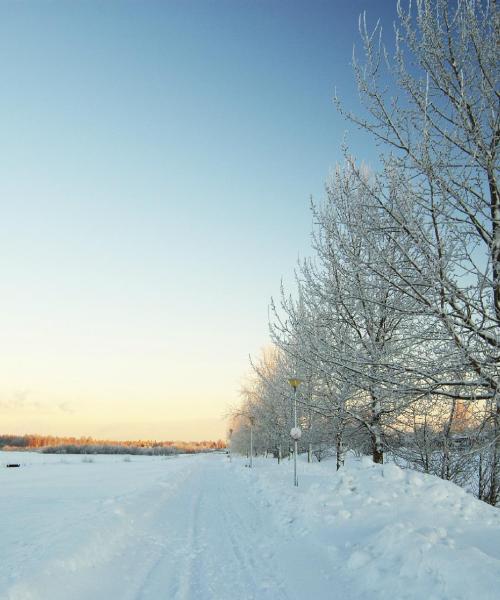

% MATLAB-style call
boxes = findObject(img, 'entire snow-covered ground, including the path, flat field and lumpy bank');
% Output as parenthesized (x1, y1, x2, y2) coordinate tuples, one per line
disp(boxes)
(0, 453, 500, 600)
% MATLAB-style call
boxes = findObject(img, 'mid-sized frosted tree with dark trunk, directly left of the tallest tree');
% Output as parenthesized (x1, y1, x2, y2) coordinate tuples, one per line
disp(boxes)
(305, 169, 424, 462)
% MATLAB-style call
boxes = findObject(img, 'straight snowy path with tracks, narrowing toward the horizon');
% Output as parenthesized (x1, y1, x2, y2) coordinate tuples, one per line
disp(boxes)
(124, 460, 296, 600)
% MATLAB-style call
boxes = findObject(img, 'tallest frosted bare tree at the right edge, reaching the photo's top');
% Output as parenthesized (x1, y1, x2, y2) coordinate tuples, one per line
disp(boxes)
(339, 0, 500, 504)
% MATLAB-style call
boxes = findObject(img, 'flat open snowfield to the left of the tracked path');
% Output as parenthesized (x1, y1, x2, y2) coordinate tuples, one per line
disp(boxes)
(0, 452, 196, 600)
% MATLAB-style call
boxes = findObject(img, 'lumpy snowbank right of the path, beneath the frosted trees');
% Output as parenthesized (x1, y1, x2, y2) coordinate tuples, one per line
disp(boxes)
(233, 458, 500, 600)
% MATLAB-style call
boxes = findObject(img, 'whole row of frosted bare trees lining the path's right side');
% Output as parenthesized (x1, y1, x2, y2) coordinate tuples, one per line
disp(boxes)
(232, 0, 500, 504)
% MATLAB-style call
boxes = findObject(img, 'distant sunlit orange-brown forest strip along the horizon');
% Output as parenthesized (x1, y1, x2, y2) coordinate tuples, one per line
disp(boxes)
(0, 434, 226, 456)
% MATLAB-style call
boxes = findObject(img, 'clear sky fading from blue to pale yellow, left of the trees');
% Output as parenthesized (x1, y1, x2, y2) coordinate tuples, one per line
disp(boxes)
(0, 0, 395, 439)
